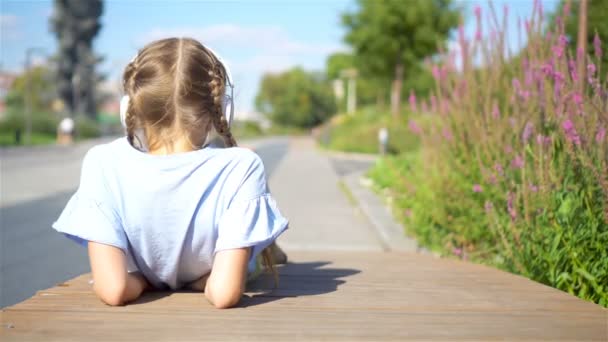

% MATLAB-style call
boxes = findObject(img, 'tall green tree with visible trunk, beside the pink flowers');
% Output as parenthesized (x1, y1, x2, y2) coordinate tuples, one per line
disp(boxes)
(342, 0, 460, 116)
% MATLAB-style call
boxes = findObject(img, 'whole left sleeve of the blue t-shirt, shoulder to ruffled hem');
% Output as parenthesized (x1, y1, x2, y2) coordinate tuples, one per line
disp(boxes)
(52, 148, 128, 253)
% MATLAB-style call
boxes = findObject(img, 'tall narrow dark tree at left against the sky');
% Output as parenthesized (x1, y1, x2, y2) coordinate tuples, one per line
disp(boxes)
(51, 0, 103, 119)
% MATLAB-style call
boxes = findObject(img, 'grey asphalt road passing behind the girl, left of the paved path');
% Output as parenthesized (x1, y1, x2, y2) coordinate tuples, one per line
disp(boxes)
(0, 138, 288, 307)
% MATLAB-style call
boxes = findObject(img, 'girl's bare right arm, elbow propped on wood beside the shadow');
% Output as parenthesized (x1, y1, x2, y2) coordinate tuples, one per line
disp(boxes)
(205, 248, 251, 309)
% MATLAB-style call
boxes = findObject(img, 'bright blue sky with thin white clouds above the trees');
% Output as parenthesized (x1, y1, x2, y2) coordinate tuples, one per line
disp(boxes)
(0, 0, 558, 115)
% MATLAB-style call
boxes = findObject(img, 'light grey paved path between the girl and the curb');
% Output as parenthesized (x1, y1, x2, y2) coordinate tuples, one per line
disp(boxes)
(270, 138, 383, 251)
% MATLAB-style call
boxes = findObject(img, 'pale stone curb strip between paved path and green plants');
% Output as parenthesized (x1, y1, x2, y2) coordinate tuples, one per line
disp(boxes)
(342, 172, 431, 254)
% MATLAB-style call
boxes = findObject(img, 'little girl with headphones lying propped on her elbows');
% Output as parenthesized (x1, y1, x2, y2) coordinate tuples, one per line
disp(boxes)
(53, 38, 288, 308)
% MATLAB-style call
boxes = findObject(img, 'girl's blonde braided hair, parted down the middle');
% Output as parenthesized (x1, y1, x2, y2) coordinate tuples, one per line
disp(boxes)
(123, 38, 277, 281)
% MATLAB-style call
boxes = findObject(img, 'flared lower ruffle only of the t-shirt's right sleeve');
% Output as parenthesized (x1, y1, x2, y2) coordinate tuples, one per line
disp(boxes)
(215, 193, 288, 271)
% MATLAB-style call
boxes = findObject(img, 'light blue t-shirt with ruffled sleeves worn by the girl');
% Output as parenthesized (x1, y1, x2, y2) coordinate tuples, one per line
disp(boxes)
(52, 137, 288, 289)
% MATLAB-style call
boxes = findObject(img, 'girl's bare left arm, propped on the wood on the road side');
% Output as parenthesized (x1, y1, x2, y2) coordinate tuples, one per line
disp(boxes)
(89, 241, 149, 306)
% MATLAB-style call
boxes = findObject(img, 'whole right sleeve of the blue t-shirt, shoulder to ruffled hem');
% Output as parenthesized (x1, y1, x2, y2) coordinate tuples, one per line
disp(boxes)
(215, 151, 289, 270)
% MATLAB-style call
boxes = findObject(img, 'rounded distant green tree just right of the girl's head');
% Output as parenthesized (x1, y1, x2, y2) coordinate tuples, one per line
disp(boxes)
(255, 68, 336, 128)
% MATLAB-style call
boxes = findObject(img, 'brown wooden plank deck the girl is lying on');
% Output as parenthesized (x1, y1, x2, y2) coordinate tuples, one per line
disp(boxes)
(0, 252, 608, 341)
